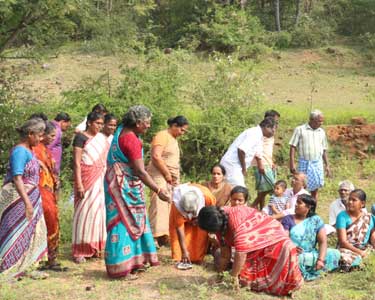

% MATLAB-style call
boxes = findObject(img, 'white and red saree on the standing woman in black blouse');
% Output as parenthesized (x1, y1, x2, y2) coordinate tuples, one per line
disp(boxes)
(72, 133, 109, 258)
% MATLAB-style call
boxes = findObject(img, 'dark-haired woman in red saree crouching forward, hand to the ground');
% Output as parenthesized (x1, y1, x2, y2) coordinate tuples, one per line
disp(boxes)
(198, 206, 303, 296)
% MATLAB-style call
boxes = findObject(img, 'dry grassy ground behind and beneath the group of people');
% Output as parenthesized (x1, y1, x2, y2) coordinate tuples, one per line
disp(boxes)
(0, 46, 375, 300)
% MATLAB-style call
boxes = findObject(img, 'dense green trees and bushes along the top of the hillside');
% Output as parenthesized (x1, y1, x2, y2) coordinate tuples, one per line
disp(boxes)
(0, 0, 375, 57)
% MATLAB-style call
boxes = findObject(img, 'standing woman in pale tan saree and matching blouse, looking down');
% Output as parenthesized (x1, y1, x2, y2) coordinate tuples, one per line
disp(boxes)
(147, 116, 189, 246)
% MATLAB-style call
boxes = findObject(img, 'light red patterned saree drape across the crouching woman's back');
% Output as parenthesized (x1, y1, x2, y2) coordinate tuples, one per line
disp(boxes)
(219, 206, 288, 253)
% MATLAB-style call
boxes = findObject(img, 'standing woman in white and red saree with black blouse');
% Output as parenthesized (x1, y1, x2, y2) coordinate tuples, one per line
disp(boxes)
(72, 112, 109, 263)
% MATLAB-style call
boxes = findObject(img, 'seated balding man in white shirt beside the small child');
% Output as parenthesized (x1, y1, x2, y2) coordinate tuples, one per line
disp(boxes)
(272, 172, 309, 220)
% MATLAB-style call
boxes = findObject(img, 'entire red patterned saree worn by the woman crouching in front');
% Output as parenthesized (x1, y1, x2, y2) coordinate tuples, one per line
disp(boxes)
(224, 206, 303, 296)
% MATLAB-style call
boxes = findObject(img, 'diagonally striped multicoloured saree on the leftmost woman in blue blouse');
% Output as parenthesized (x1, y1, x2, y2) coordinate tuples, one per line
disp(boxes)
(0, 152, 47, 277)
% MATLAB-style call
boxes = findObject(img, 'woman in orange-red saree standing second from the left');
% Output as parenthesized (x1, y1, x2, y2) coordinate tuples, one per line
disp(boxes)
(33, 122, 61, 271)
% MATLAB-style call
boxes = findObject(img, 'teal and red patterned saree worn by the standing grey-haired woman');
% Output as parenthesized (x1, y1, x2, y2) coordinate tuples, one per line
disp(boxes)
(104, 126, 159, 278)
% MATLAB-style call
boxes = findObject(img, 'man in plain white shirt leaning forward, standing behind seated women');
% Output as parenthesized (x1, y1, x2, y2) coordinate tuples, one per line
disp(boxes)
(220, 117, 276, 187)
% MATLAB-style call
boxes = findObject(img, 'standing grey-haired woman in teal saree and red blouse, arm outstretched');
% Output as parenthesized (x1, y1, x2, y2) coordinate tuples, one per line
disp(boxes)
(104, 105, 170, 279)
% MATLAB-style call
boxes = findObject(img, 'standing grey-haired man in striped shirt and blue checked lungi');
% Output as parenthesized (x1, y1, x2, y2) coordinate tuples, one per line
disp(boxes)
(289, 110, 331, 200)
